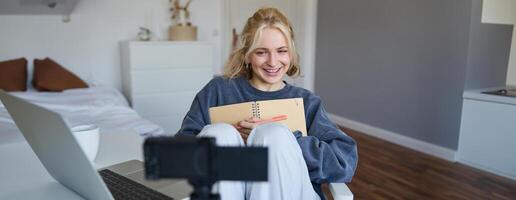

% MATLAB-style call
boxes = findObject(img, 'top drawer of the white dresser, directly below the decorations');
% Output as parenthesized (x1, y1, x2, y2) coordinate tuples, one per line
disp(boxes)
(130, 43, 213, 69)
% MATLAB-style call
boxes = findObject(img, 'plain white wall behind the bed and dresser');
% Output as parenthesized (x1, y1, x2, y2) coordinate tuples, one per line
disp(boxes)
(0, 0, 223, 89)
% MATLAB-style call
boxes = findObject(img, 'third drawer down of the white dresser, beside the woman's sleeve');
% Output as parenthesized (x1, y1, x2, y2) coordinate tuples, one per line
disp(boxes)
(132, 92, 197, 116)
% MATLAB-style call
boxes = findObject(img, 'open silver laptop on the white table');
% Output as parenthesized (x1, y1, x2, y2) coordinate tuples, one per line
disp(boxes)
(0, 90, 192, 200)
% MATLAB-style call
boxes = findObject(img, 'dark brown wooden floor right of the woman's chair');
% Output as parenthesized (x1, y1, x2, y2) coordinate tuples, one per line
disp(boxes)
(322, 128, 516, 200)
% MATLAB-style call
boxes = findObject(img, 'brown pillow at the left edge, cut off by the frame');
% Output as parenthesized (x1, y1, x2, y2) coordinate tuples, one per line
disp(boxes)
(0, 58, 27, 92)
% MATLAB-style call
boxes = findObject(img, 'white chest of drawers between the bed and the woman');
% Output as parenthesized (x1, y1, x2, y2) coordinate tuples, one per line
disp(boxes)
(121, 41, 214, 134)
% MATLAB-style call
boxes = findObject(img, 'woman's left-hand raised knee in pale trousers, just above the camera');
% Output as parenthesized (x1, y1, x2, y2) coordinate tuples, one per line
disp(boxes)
(199, 123, 243, 146)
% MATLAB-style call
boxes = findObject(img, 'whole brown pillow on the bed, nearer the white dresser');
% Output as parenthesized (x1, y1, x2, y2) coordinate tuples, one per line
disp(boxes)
(32, 58, 88, 92)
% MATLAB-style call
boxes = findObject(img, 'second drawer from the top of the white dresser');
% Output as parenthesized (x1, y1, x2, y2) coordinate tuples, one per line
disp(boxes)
(132, 68, 213, 95)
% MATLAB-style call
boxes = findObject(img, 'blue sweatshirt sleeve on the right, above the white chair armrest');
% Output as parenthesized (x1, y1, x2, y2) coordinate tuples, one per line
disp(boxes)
(298, 95, 358, 184)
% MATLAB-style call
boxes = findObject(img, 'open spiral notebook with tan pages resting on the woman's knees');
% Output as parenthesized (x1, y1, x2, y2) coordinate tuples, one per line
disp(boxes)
(209, 98, 307, 136)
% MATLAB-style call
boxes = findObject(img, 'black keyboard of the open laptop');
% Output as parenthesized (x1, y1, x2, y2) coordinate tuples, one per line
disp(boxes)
(99, 169, 173, 200)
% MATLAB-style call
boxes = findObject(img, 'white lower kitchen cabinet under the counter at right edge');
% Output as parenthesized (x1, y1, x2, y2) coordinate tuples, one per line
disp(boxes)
(458, 90, 516, 180)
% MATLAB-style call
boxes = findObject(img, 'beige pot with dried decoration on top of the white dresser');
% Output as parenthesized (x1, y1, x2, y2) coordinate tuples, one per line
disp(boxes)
(169, 0, 197, 41)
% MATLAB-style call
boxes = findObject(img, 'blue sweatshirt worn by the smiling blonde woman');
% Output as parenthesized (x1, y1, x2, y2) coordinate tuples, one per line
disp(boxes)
(178, 77, 358, 197)
